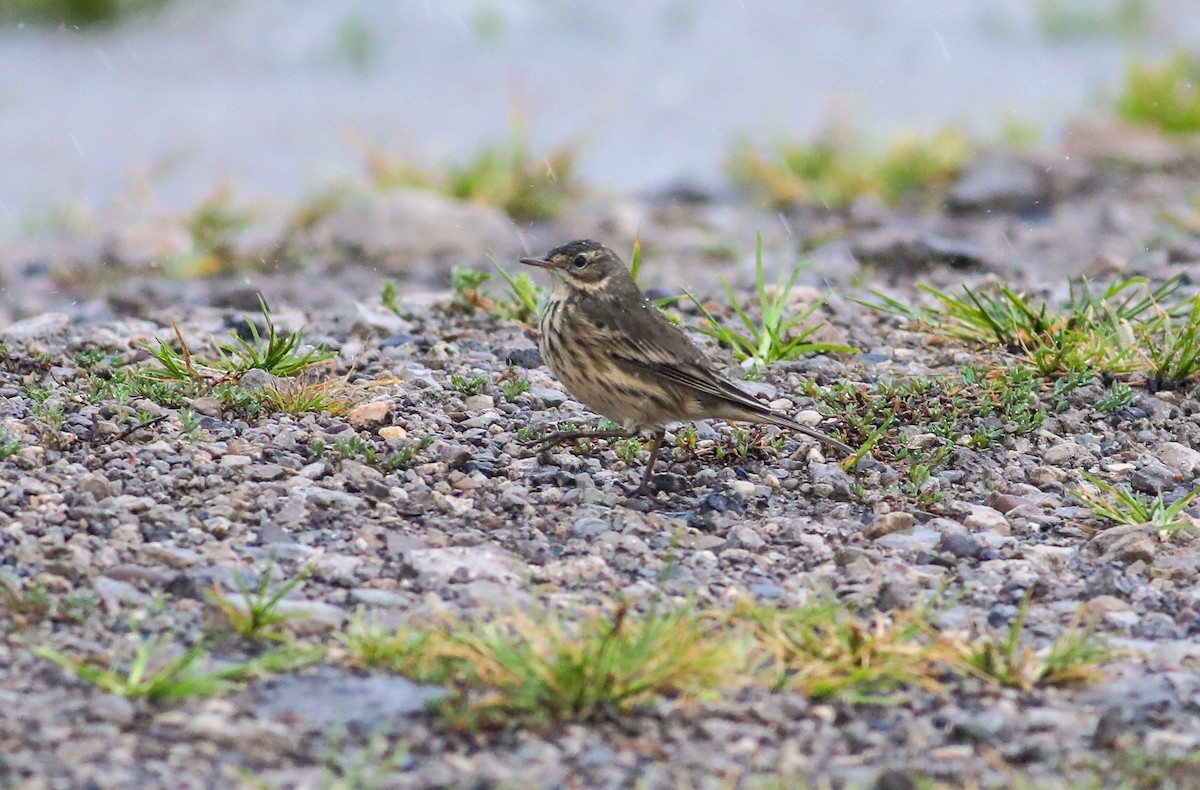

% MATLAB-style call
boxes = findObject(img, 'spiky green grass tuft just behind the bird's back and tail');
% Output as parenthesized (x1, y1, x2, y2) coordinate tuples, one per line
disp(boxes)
(688, 233, 857, 367)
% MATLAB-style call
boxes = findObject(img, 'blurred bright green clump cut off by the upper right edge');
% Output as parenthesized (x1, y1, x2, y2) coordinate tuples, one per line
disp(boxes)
(1116, 50, 1200, 134)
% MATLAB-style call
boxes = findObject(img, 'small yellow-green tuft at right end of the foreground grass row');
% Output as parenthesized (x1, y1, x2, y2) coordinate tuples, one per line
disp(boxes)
(960, 594, 1114, 692)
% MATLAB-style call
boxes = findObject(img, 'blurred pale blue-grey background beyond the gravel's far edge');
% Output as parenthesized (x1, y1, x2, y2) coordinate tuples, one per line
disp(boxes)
(0, 0, 1200, 228)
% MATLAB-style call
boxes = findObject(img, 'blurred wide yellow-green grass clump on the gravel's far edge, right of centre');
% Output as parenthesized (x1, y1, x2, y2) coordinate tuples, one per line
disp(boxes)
(726, 127, 972, 209)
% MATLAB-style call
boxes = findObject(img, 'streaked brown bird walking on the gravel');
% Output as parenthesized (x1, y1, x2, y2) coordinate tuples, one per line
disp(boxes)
(521, 239, 854, 495)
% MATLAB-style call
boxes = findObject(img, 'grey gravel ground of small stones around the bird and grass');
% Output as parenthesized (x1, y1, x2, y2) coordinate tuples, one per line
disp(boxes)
(0, 132, 1200, 788)
